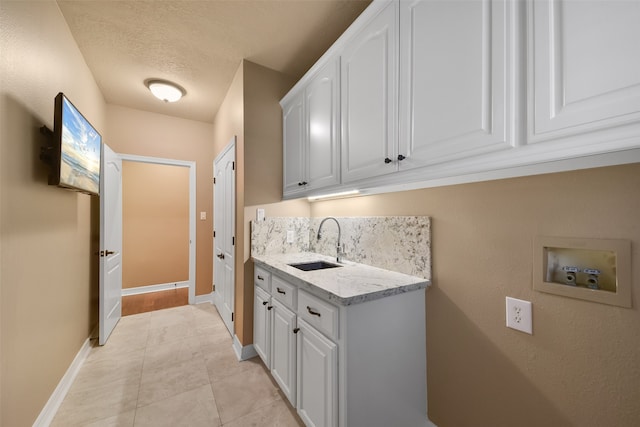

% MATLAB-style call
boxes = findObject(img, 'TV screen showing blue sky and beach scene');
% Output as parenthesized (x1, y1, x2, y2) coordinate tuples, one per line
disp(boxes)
(60, 98, 102, 194)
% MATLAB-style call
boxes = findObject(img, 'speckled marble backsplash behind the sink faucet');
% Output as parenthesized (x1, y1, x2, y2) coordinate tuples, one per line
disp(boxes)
(251, 216, 431, 280)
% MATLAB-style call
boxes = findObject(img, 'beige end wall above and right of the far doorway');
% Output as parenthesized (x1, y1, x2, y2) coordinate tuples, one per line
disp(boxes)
(105, 104, 214, 295)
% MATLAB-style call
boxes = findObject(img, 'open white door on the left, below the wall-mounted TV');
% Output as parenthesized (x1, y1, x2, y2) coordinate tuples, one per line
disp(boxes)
(98, 144, 122, 345)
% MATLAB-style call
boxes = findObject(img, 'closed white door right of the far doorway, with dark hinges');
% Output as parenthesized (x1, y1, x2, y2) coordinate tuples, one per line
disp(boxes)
(213, 137, 236, 336)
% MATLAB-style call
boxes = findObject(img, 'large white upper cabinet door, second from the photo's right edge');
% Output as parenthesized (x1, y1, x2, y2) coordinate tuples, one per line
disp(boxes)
(399, 0, 515, 170)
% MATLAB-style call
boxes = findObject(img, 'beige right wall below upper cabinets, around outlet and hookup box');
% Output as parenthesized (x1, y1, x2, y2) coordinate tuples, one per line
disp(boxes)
(311, 164, 640, 427)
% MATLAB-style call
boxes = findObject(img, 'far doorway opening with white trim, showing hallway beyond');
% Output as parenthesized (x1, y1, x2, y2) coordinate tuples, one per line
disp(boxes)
(121, 154, 196, 315)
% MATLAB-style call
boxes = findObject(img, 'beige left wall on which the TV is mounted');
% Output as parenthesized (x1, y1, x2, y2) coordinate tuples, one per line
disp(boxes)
(0, 1, 108, 426)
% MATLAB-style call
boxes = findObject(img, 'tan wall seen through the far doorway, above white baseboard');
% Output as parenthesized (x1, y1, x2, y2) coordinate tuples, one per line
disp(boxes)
(122, 161, 189, 288)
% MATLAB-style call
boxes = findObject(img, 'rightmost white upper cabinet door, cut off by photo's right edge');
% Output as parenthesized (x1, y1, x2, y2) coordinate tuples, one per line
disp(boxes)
(529, 0, 640, 146)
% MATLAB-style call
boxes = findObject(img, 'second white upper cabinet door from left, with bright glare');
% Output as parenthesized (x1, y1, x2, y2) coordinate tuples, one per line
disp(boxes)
(305, 58, 340, 190)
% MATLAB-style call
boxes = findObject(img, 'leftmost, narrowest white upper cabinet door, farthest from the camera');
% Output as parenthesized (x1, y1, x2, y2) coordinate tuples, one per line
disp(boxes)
(282, 92, 307, 196)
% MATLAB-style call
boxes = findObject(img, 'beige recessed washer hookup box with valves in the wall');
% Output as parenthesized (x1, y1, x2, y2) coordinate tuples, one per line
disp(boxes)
(533, 236, 631, 307)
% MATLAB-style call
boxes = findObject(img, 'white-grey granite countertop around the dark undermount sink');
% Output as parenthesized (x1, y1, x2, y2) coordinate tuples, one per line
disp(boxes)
(252, 252, 431, 305)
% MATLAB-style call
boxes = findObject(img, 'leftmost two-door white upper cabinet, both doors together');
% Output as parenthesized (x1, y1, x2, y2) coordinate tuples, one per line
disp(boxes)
(282, 58, 340, 197)
